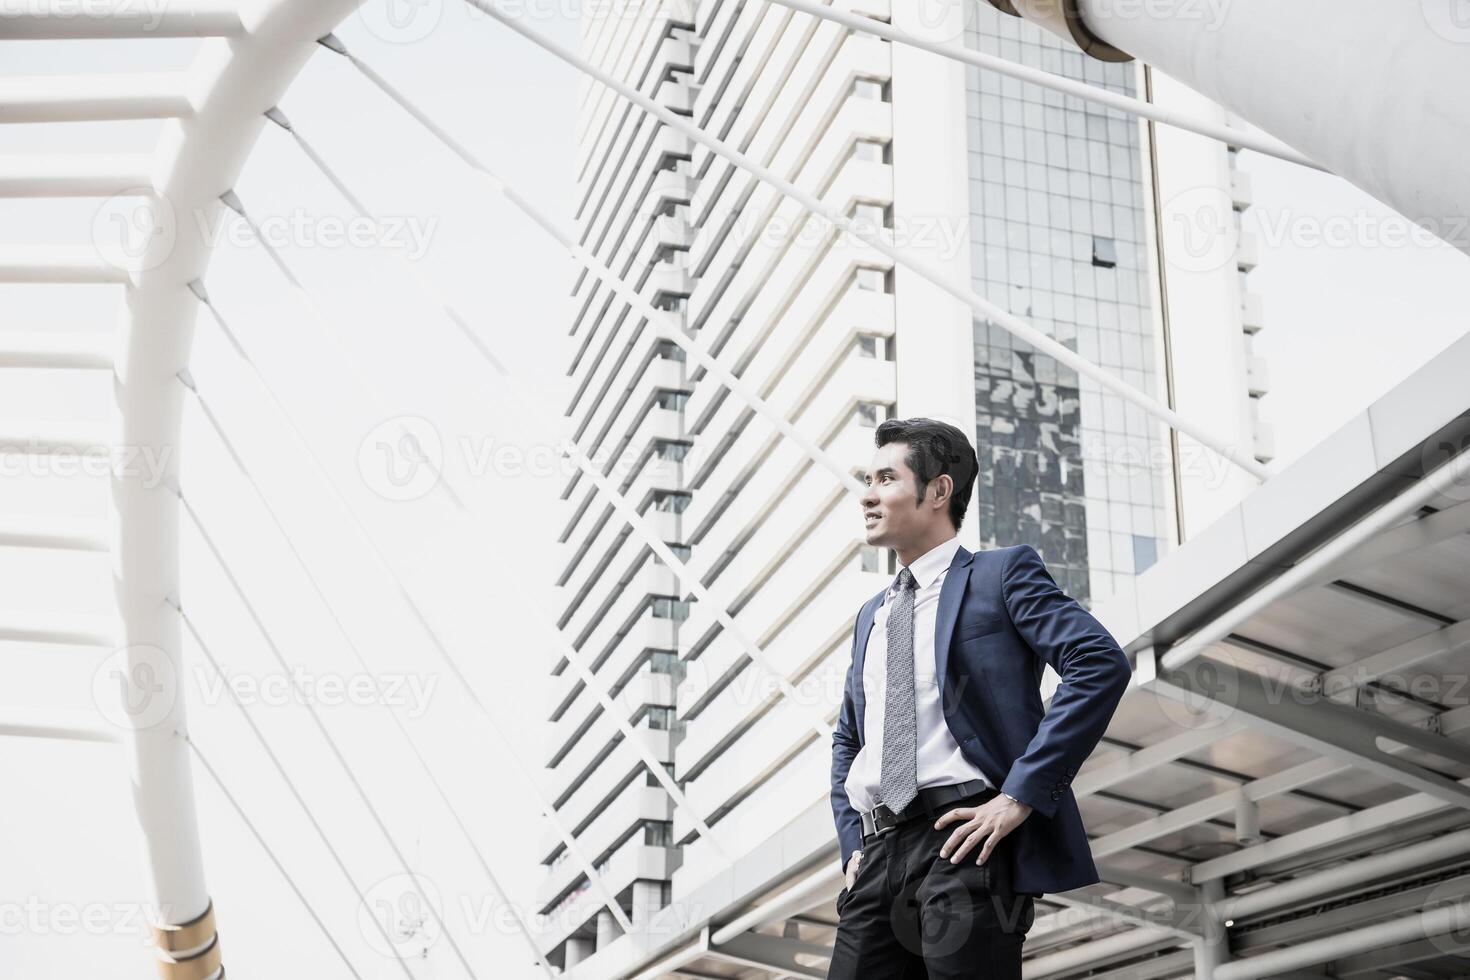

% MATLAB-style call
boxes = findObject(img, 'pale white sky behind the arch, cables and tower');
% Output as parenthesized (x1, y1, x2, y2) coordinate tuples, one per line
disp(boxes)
(0, 0, 1470, 980)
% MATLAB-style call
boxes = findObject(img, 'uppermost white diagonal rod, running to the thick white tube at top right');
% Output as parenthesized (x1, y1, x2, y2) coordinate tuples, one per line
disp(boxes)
(770, 0, 1323, 170)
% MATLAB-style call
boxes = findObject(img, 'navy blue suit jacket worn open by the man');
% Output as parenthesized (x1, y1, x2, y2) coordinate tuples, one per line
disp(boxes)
(832, 545, 1132, 895)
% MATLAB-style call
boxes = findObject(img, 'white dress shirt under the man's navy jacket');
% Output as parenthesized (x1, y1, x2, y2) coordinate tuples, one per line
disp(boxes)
(844, 535, 989, 813)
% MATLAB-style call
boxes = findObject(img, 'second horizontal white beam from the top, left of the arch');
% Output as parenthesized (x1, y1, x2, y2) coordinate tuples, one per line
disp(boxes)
(0, 72, 194, 123)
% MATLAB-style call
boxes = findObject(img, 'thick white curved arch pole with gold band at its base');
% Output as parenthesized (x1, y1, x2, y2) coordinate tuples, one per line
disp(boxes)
(107, 0, 367, 977)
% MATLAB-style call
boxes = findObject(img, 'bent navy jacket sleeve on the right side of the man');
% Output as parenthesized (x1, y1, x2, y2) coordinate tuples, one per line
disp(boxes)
(1001, 545, 1132, 818)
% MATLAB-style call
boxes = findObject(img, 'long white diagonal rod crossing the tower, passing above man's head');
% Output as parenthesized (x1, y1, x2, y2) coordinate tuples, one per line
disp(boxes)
(466, 0, 1270, 480)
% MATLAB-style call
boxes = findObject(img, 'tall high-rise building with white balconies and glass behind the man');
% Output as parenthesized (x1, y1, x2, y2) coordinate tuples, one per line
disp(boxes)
(537, 0, 1263, 977)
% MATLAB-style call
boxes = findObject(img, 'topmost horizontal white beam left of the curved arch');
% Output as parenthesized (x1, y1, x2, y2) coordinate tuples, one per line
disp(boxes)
(0, 0, 245, 41)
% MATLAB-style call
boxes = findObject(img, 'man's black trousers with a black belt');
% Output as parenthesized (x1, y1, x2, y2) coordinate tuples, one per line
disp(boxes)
(828, 790, 1036, 980)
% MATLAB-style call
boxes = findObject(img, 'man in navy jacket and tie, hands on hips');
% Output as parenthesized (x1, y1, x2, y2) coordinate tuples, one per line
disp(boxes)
(828, 419, 1130, 980)
